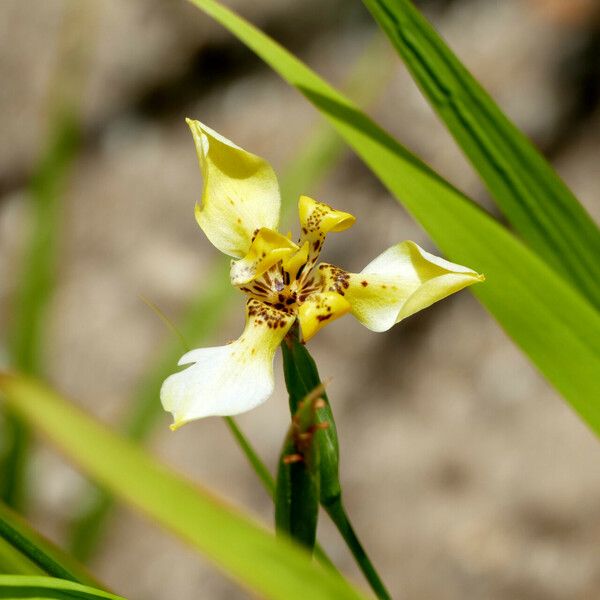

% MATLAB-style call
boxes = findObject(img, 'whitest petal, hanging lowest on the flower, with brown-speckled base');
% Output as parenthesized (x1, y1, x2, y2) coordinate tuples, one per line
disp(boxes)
(160, 299, 295, 429)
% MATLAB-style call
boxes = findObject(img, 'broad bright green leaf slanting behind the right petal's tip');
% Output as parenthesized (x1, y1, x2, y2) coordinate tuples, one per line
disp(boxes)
(190, 0, 600, 433)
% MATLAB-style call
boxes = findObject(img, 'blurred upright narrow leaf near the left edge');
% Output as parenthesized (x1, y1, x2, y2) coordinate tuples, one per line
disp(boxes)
(0, 3, 94, 510)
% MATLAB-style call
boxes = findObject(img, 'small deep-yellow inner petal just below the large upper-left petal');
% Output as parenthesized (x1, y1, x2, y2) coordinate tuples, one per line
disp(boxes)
(230, 227, 298, 285)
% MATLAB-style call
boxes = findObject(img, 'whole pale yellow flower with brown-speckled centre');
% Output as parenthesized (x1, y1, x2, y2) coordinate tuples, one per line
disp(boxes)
(160, 119, 483, 429)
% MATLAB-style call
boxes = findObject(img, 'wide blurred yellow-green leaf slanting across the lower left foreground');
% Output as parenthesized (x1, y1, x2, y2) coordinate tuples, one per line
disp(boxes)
(0, 375, 364, 600)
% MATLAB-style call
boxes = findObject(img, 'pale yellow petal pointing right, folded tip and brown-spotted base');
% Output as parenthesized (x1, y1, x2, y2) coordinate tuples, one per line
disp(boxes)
(319, 241, 484, 331)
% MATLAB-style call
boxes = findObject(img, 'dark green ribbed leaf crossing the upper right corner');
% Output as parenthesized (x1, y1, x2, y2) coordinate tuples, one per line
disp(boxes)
(363, 0, 600, 307)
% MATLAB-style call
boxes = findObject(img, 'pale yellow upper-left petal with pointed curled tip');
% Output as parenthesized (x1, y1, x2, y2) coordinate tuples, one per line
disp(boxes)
(187, 119, 280, 258)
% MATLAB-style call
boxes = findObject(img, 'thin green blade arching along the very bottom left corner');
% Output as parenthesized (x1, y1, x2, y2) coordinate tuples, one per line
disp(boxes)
(0, 575, 124, 600)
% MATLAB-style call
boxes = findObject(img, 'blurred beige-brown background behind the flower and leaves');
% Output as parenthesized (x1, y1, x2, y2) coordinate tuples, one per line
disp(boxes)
(0, 0, 600, 600)
